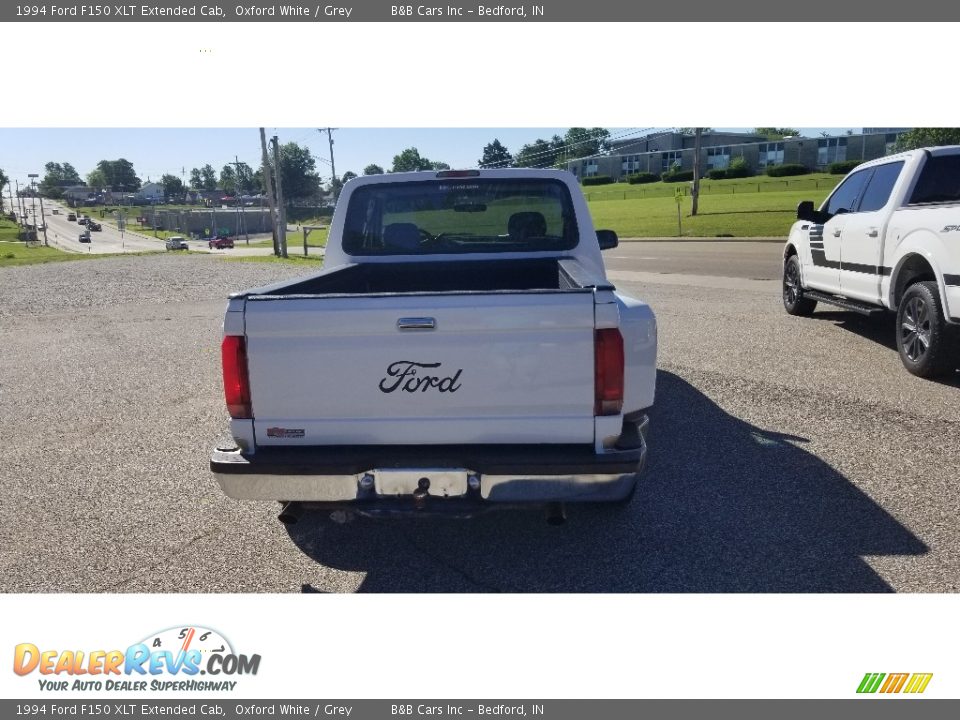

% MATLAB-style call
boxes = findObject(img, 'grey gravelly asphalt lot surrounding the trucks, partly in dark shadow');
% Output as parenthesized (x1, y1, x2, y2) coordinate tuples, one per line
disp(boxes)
(0, 243, 960, 593)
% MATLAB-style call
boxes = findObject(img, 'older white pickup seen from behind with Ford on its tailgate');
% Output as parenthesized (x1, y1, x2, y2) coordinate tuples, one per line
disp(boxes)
(210, 170, 657, 522)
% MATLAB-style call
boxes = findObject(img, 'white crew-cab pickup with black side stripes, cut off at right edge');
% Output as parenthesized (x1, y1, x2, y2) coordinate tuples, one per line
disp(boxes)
(783, 146, 960, 377)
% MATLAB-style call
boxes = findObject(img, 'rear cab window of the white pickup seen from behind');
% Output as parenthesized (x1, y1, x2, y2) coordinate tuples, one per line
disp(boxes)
(343, 177, 579, 255)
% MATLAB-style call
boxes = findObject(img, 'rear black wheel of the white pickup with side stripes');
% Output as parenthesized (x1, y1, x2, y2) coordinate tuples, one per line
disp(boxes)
(897, 280, 951, 377)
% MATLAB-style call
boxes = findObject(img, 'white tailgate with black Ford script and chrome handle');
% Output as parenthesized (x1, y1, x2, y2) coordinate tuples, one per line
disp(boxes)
(244, 290, 594, 445)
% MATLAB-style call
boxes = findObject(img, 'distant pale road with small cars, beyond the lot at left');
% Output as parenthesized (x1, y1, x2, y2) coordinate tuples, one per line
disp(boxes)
(37, 200, 288, 255)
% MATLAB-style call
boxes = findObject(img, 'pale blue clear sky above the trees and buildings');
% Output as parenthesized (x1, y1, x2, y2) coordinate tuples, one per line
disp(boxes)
(0, 128, 859, 190)
